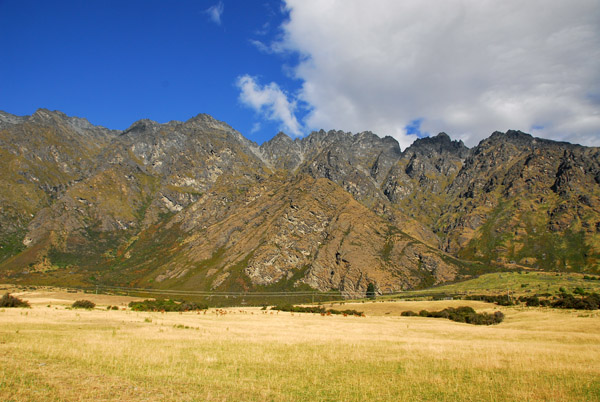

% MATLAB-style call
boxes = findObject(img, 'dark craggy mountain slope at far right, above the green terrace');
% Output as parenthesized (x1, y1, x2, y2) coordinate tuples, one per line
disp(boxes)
(441, 131, 600, 271)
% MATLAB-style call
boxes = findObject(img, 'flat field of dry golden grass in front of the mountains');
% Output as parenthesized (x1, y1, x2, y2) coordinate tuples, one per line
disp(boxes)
(0, 292, 600, 401)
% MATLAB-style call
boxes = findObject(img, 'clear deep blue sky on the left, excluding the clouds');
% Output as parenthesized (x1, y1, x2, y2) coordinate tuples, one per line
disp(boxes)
(0, 0, 297, 142)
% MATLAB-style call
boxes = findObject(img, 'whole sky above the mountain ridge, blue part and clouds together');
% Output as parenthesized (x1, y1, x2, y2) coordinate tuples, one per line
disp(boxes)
(0, 0, 600, 148)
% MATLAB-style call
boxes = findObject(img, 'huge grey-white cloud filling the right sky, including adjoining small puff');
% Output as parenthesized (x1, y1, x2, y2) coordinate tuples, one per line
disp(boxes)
(274, 0, 600, 147)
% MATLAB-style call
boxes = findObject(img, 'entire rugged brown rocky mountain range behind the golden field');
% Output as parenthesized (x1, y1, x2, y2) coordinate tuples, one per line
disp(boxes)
(0, 109, 600, 296)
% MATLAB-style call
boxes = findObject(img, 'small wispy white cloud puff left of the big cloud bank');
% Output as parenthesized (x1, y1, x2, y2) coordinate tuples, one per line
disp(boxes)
(236, 75, 302, 136)
